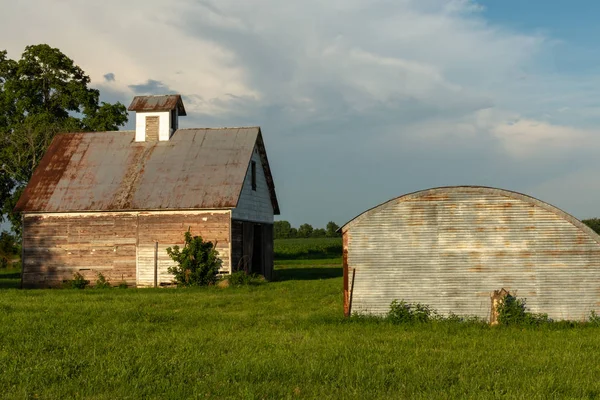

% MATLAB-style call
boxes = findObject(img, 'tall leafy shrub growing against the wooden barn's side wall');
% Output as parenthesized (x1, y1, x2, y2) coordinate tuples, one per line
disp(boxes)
(167, 231, 222, 286)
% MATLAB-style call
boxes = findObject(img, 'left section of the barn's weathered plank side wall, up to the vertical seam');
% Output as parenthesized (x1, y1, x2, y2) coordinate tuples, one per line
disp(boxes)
(23, 214, 137, 287)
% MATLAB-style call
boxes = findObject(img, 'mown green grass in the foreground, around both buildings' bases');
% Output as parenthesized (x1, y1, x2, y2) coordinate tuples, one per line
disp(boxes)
(0, 259, 600, 399)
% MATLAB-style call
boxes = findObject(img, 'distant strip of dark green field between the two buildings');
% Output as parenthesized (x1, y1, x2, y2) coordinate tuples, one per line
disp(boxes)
(274, 238, 342, 260)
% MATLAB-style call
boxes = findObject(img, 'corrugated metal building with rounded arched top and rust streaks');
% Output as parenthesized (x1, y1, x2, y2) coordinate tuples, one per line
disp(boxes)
(341, 186, 600, 320)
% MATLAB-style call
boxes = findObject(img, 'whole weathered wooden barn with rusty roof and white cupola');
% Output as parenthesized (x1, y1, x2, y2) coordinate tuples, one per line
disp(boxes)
(15, 95, 279, 287)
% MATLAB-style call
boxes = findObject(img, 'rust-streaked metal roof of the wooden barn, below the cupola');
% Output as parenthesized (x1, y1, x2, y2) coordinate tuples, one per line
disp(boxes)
(15, 127, 279, 214)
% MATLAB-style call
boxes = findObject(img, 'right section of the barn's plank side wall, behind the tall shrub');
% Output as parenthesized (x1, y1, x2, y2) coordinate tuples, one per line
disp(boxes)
(137, 212, 231, 286)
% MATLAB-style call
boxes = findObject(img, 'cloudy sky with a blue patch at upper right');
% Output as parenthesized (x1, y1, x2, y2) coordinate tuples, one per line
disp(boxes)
(0, 0, 600, 226)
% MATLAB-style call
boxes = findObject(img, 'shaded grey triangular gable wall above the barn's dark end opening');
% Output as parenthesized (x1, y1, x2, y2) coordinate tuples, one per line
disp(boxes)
(232, 148, 273, 224)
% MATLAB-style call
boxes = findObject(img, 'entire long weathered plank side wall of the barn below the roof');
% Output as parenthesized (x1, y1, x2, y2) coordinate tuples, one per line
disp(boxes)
(23, 210, 231, 287)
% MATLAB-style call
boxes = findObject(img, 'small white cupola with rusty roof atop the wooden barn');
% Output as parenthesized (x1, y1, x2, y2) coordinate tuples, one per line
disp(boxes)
(128, 94, 186, 142)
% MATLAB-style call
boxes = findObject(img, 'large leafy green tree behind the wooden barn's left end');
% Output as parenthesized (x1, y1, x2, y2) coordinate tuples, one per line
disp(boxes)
(0, 44, 127, 233)
